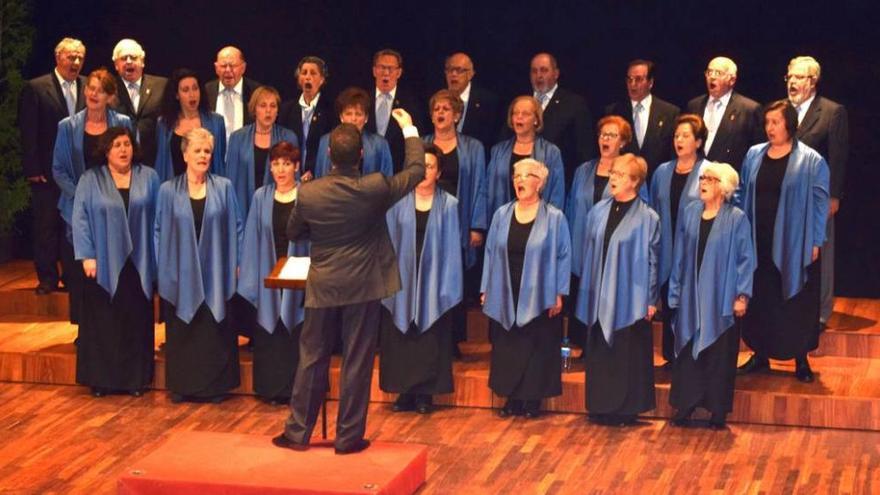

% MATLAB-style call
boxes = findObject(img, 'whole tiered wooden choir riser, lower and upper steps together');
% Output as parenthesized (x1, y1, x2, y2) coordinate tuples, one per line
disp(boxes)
(0, 262, 880, 431)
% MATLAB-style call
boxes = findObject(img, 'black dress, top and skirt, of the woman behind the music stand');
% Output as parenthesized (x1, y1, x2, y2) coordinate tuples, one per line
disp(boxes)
(248, 200, 302, 403)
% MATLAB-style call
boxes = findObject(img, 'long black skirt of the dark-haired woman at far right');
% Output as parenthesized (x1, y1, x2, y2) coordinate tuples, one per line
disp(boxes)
(742, 260, 821, 359)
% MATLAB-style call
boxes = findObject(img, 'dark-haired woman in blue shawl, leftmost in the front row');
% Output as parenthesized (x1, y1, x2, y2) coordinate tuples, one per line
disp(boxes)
(72, 127, 159, 397)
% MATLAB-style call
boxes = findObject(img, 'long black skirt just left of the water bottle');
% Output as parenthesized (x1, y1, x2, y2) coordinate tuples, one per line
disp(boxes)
(489, 311, 562, 400)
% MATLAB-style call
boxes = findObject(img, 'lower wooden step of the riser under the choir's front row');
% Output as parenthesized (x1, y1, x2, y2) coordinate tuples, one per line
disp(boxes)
(0, 316, 880, 431)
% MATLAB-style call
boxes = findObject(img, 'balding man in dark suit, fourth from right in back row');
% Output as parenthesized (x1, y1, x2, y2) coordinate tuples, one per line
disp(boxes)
(529, 53, 596, 184)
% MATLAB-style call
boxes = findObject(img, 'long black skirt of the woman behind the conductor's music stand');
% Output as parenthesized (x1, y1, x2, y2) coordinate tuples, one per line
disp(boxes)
(253, 319, 302, 399)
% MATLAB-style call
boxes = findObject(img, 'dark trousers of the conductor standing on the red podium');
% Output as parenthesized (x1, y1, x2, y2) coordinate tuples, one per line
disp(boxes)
(284, 300, 380, 449)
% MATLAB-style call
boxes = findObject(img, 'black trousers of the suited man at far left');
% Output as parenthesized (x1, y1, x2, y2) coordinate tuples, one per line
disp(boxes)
(31, 183, 65, 288)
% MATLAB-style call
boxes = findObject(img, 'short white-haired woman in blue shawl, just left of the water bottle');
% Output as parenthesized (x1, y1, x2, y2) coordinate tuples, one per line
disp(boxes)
(480, 159, 571, 418)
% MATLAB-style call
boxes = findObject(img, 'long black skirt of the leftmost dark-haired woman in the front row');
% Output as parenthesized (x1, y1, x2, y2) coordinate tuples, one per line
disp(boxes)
(76, 259, 154, 391)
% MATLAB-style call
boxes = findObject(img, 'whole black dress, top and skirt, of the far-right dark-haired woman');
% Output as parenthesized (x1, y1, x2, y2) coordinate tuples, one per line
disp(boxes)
(742, 155, 820, 359)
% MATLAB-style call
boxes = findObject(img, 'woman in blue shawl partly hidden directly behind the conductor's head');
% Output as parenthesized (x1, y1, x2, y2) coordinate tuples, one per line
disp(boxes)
(315, 87, 394, 179)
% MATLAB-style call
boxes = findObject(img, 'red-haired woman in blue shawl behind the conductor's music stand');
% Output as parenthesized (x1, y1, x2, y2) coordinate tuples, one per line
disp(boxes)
(238, 141, 309, 404)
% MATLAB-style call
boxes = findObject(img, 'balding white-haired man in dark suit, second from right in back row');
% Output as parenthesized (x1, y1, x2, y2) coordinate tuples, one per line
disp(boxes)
(687, 57, 767, 171)
